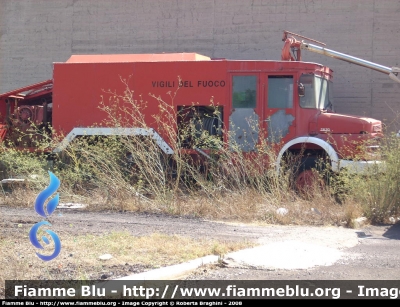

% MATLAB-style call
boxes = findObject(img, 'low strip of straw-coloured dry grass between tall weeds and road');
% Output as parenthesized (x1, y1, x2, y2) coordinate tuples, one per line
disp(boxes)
(3, 188, 363, 226)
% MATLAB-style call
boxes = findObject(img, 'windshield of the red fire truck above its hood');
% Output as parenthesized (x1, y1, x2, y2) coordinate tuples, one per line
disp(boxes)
(299, 74, 333, 111)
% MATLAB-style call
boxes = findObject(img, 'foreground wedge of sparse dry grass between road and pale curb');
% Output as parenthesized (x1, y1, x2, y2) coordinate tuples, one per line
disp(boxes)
(0, 231, 252, 296)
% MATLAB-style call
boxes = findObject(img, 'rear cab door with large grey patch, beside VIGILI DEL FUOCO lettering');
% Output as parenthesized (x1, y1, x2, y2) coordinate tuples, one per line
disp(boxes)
(228, 73, 261, 152)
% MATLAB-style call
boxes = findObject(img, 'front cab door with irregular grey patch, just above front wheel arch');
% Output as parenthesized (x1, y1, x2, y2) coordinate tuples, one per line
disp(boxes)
(263, 74, 295, 144)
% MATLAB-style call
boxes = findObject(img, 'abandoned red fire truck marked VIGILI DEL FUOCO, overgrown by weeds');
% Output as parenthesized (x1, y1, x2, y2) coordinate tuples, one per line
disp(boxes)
(0, 31, 394, 189)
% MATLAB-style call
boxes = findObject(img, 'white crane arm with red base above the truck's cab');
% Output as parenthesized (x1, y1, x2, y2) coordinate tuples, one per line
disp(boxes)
(282, 31, 400, 83)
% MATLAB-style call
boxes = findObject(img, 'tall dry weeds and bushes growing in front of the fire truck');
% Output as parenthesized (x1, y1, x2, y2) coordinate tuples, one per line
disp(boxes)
(1, 79, 400, 225)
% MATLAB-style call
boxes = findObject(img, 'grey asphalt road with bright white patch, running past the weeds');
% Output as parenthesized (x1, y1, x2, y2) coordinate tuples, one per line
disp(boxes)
(0, 206, 400, 280)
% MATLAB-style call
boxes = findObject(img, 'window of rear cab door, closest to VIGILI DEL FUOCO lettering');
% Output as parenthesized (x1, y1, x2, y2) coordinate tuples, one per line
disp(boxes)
(232, 76, 257, 108)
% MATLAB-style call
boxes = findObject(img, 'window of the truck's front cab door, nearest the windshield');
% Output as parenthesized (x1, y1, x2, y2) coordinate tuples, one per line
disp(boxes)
(268, 76, 293, 109)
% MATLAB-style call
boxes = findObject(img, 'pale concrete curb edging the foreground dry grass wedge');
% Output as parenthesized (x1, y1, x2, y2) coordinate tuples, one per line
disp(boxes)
(114, 255, 219, 280)
